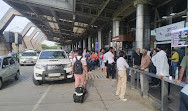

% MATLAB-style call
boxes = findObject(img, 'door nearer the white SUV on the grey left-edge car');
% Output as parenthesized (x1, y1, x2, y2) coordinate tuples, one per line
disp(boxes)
(8, 57, 17, 76)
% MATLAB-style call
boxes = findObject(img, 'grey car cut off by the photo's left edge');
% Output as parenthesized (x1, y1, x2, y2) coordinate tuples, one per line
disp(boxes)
(0, 56, 20, 89)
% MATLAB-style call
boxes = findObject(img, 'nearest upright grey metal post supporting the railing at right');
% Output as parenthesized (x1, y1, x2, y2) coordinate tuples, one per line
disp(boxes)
(161, 80, 168, 111)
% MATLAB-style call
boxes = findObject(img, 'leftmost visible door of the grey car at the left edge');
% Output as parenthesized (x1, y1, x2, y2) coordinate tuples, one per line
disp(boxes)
(2, 58, 10, 80)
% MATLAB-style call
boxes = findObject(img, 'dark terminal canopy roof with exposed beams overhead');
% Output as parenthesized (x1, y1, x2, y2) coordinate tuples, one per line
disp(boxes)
(4, 0, 167, 44)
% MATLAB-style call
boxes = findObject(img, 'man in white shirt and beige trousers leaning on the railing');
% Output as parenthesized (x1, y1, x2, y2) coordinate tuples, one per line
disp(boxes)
(116, 51, 129, 101)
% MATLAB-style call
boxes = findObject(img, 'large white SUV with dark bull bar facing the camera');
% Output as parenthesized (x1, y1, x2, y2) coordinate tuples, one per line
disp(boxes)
(33, 50, 73, 85)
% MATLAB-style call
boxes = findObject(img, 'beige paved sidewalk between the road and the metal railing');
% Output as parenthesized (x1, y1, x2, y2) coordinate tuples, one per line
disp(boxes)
(85, 70, 154, 111)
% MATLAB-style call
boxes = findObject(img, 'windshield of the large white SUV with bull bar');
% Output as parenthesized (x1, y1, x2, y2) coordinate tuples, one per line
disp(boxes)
(39, 51, 67, 59)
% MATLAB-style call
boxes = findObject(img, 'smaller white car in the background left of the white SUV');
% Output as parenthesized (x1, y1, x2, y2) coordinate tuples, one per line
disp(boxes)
(20, 50, 38, 66)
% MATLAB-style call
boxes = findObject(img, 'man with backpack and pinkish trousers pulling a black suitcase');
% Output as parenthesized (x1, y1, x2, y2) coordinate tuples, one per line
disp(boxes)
(72, 49, 89, 89)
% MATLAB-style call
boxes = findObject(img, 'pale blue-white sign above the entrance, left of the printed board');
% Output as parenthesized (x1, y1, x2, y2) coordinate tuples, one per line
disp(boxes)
(156, 21, 185, 41)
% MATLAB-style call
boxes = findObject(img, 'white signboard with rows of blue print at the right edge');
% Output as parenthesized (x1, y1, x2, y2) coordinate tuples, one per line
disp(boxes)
(171, 27, 188, 47)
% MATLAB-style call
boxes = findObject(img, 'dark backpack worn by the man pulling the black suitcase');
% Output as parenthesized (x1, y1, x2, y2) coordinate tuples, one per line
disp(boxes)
(73, 57, 83, 74)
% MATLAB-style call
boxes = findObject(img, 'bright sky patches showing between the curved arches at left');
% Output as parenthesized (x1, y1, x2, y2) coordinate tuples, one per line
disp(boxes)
(0, 0, 55, 46)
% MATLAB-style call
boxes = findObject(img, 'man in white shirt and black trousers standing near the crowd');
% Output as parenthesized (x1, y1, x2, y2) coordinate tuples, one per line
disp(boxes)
(104, 47, 115, 79)
